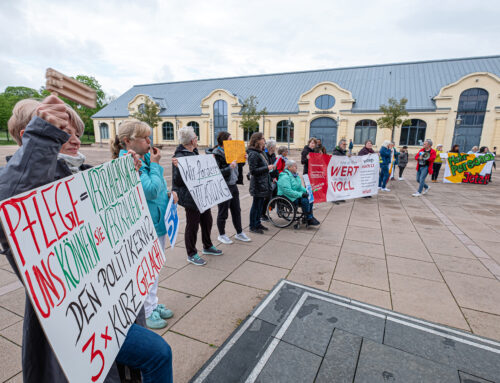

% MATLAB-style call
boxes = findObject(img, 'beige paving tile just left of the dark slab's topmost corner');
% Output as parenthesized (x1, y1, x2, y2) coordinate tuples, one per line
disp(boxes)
(226, 261, 288, 290)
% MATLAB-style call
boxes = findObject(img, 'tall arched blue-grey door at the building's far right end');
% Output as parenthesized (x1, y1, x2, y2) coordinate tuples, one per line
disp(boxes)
(452, 88, 488, 153)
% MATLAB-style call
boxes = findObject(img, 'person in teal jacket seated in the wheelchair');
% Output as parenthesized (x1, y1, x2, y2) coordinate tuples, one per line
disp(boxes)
(278, 160, 319, 226)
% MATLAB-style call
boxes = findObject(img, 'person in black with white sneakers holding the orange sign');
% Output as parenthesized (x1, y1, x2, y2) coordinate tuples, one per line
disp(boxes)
(212, 132, 250, 245)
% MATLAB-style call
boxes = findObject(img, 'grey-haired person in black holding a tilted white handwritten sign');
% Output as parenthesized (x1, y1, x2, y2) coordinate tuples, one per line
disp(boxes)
(172, 126, 222, 266)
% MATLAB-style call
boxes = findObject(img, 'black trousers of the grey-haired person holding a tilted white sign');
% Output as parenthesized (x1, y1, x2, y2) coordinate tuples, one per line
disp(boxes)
(184, 208, 213, 257)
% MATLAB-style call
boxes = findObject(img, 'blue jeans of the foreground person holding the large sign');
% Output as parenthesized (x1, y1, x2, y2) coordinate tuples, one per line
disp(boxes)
(116, 323, 173, 383)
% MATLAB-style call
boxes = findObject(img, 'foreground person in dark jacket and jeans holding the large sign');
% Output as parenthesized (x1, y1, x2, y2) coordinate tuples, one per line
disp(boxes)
(0, 96, 172, 383)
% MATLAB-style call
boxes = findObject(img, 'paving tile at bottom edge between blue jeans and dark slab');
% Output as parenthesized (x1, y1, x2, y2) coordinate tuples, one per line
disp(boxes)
(163, 331, 216, 383)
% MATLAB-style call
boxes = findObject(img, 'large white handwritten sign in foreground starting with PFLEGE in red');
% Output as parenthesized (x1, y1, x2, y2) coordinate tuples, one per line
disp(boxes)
(0, 156, 165, 382)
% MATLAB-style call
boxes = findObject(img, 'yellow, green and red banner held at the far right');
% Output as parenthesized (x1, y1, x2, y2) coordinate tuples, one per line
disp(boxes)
(441, 153, 495, 185)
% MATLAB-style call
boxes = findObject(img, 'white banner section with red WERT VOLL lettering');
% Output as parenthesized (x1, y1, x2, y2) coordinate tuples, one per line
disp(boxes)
(326, 154, 380, 201)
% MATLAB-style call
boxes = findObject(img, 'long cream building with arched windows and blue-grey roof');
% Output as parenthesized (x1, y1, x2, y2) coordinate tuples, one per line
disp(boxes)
(93, 56, 500, 152)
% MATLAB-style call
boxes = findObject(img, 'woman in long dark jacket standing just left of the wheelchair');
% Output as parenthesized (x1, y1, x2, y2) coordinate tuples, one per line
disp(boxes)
(248, 132, 273, 234)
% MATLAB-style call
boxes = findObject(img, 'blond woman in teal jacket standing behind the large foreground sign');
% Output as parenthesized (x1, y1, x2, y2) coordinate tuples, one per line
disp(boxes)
(111, 120, 177, 329)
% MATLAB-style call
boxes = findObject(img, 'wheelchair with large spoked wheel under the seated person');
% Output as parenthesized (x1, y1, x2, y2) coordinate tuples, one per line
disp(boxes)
(266, 196, 309, 229)
